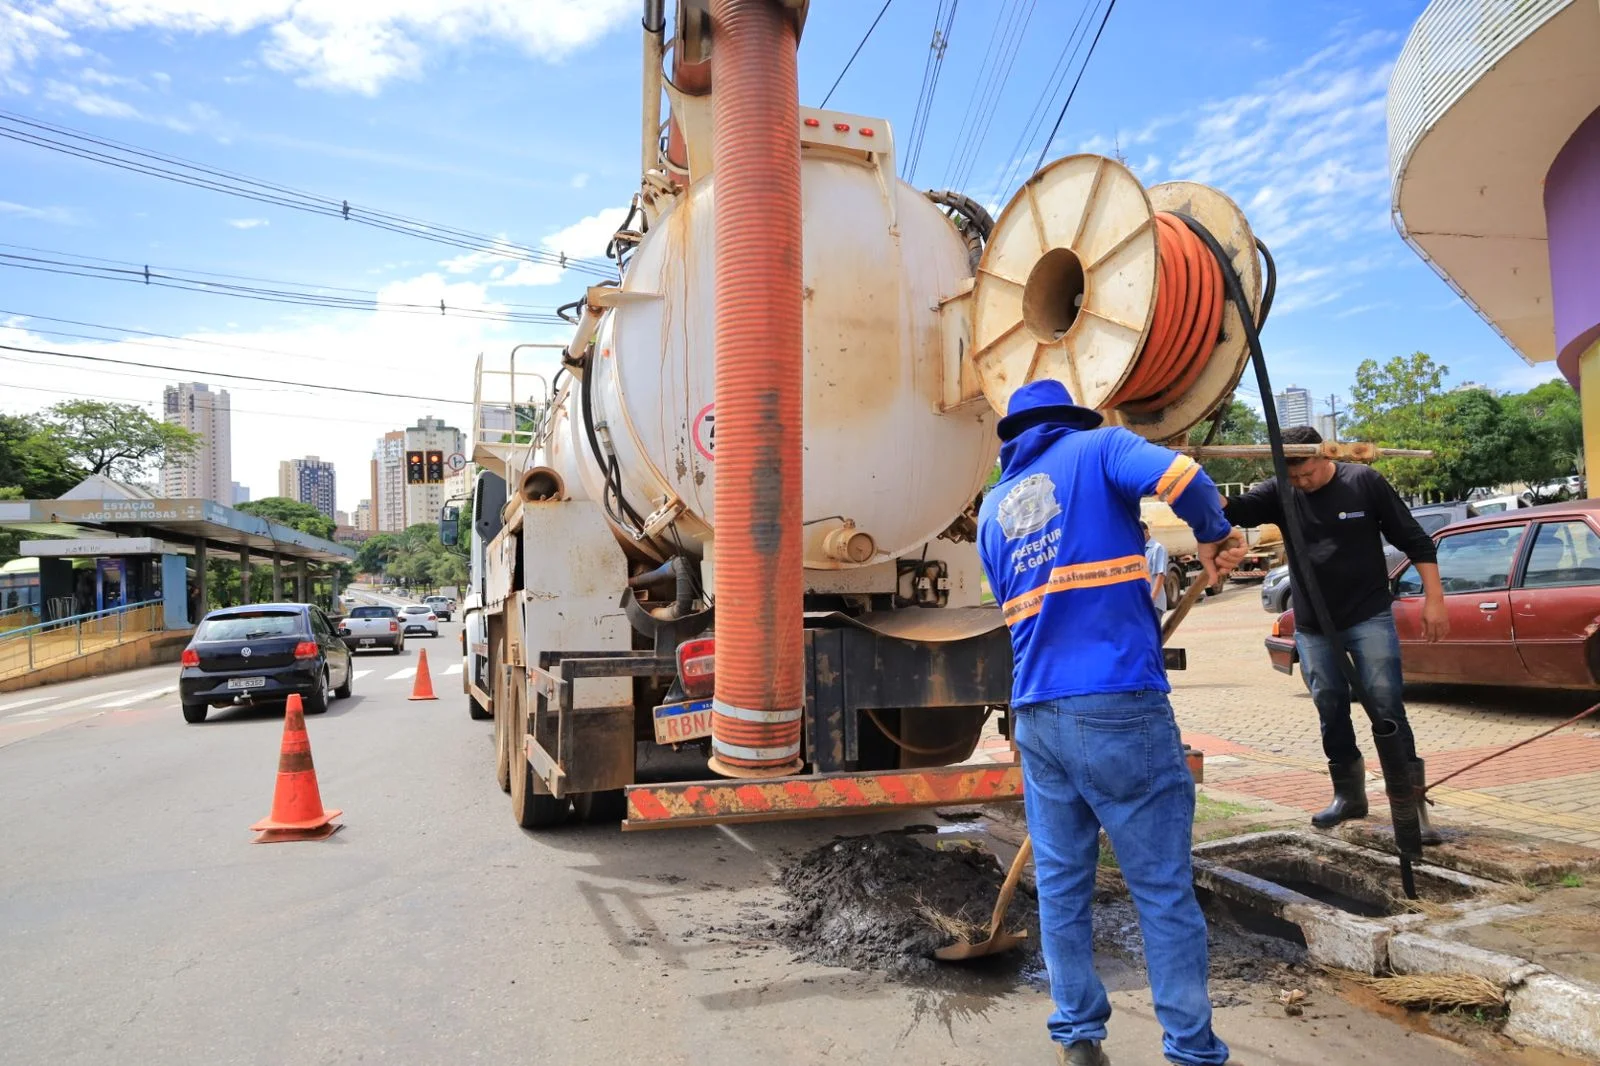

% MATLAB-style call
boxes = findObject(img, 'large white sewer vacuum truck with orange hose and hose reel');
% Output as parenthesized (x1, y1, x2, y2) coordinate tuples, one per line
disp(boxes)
(443, 0, 1262, 829)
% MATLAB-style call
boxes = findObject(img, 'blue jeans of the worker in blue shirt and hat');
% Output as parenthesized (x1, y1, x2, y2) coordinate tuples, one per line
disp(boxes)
(1013, 691, 1227, 1066)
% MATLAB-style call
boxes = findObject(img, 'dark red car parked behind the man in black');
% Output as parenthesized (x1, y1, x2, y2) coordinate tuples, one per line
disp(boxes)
(1267, 499, 1600, 690)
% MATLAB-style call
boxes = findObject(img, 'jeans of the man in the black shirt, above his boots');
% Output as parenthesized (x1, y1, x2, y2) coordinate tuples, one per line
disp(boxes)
(1294, 611, 1416, 765)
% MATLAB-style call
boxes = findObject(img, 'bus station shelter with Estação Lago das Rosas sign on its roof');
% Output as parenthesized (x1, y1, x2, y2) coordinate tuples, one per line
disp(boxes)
(0, 493, 355, 629)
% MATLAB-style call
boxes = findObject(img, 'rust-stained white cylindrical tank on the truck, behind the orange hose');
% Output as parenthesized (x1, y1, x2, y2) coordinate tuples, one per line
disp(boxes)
(549, 150, 998, 568)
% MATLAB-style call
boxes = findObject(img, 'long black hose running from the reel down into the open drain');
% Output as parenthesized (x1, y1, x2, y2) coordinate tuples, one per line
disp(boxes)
(1178, 213, 1422, 870)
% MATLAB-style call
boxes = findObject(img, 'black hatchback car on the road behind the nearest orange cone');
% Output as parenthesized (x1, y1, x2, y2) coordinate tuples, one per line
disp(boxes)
(178, 603, 354, 722)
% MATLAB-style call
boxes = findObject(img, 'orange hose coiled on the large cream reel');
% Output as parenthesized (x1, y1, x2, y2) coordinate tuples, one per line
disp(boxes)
(1106, 211, 1222, 413)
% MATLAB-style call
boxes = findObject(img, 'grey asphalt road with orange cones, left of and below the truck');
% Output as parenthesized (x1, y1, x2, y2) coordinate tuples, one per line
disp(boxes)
(0, 624, 1504, 1066)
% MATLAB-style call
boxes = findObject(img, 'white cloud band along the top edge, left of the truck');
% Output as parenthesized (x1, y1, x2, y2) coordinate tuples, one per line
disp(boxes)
(17, 0, 638, 96)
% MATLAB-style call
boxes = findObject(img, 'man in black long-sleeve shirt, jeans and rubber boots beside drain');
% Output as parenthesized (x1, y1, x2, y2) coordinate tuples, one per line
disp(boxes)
(1224, 426, 1450, 844)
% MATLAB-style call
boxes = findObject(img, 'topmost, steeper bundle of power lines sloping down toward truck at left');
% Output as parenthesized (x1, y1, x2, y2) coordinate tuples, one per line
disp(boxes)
(0, 110, 614, 277)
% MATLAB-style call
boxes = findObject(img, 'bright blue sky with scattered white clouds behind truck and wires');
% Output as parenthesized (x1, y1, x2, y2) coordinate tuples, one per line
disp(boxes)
(0, 0, 1557, 509)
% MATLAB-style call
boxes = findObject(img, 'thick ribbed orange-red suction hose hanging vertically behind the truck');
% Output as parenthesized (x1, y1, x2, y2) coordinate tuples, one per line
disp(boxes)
(710, 0, 805, 776)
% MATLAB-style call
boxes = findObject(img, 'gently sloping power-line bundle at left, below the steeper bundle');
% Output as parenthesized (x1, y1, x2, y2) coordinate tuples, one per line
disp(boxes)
(0, 251, 570, 325)
